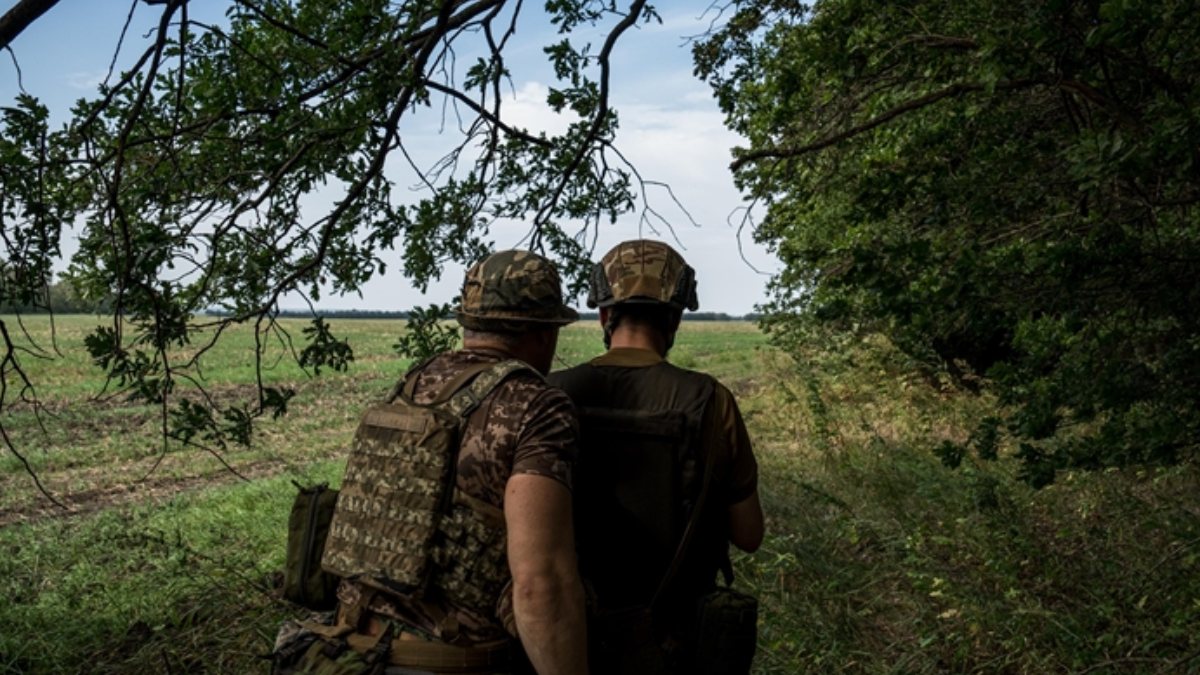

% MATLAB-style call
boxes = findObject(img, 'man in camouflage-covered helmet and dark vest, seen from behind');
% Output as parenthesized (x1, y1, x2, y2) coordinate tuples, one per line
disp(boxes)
(550, 239, 763, 674)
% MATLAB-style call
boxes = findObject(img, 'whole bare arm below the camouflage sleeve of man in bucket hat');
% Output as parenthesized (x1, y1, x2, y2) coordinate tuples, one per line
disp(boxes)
(504, 473, 587, 675)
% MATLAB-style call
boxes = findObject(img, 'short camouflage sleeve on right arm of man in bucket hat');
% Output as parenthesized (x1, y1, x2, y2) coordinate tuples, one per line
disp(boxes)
(512, 387, 580, 490)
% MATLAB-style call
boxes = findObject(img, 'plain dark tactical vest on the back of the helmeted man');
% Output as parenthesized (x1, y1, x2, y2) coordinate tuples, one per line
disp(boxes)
(550, 362, 728, 610)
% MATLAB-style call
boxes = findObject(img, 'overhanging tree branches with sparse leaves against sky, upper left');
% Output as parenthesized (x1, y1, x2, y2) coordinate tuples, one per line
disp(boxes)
(0, 0, 656, 499)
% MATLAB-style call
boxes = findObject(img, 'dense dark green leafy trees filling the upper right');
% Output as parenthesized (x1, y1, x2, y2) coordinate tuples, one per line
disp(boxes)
(695, 0, 1200, 485)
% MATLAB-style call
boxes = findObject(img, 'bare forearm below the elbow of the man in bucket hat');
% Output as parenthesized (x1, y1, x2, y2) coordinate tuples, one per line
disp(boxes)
(512, 572, 588, 675)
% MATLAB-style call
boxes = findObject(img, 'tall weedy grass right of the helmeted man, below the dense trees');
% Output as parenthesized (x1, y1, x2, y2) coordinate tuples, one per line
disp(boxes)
(734, 334, 1200, 675)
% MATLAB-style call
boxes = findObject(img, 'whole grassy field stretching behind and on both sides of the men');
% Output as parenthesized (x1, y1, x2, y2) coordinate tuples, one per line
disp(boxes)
(0, 317, 1200, 674)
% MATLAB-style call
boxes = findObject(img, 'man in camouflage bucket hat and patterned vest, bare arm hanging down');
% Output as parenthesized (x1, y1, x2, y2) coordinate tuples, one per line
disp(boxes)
(299, 251, 587, 674)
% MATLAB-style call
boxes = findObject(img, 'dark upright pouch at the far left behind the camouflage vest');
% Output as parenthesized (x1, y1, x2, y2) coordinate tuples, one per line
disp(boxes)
(283, 483, 338, 610)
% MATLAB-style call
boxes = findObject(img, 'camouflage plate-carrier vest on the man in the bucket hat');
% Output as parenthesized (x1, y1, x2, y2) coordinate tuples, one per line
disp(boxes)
(322, 360, 540, 616)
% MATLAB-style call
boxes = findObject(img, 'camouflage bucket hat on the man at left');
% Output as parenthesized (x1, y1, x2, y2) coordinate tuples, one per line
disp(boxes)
(457, 251, 580, 330)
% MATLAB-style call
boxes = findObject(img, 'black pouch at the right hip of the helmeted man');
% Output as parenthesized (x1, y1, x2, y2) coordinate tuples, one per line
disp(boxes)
(689, 587, 758, 675)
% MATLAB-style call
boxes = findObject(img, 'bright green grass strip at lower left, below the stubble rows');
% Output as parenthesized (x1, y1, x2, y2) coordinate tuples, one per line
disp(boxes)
(0, 461, 341, 674)
